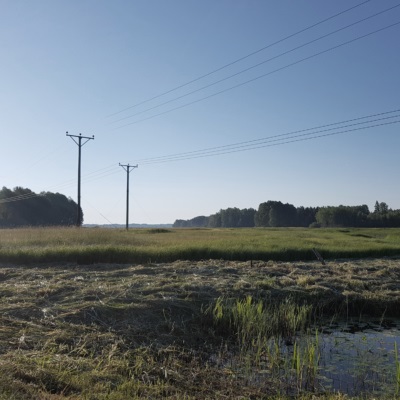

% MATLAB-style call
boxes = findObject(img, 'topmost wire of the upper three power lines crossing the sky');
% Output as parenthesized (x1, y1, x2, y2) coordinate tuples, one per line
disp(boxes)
(106, 0, 371, 118)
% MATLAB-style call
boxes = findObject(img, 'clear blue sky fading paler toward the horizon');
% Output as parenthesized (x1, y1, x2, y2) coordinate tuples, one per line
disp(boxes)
(0, 0, 400, 224)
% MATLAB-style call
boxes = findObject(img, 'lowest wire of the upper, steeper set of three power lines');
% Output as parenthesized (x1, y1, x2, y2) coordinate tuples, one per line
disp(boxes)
(114, 21, 400, 130)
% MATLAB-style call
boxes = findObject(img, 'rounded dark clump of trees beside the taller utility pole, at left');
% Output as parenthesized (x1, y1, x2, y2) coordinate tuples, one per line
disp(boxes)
(0, 187, 83, 228)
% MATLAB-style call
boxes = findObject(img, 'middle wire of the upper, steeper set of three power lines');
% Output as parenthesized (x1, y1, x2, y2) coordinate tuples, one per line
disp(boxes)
(111, 4, 400, 124)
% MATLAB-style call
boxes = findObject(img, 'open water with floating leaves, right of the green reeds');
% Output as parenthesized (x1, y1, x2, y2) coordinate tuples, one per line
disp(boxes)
(316, 320, 400, 396)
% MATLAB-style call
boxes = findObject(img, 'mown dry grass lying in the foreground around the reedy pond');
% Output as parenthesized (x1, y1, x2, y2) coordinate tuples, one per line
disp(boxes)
(0, 259, 400, 399)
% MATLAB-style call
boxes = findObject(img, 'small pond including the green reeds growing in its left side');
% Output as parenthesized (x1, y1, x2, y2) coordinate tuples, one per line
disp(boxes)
(212, 320, 400, 397)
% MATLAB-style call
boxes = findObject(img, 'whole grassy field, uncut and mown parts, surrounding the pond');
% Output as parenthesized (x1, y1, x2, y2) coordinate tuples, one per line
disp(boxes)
(0, 228, 400, 400)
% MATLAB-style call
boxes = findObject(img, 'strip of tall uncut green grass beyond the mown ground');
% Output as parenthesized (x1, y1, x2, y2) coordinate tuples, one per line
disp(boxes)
(0, 228, 400, 264)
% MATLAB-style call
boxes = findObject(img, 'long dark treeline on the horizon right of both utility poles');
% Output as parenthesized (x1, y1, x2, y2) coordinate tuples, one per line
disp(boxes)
(173, 200, 400, 228)
